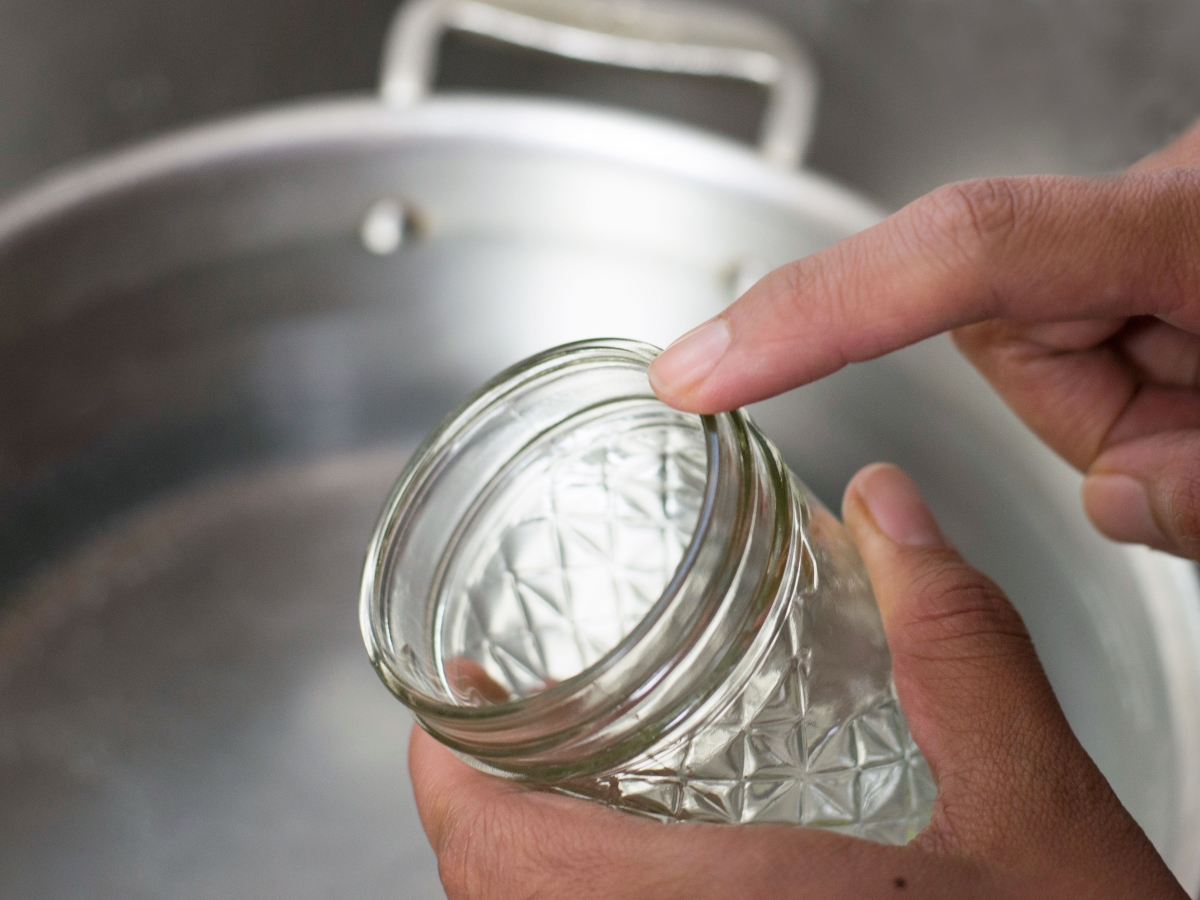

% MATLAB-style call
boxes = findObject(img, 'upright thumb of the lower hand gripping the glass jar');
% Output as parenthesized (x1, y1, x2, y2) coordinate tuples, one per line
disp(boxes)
(844, 464, 1153, 871)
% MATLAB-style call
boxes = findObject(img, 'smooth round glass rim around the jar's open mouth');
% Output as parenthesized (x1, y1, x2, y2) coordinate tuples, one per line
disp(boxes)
(360, 338, 733, 745)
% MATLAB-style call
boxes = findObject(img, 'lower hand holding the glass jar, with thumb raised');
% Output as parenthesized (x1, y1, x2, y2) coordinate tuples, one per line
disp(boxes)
(409, 466, 1186, 900)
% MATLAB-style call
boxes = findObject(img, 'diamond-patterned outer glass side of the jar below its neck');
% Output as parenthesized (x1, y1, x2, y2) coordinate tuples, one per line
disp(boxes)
(556, 489, 936, 844)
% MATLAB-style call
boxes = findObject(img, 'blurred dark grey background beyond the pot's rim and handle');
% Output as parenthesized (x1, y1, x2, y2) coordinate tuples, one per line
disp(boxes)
(7, 0, 1200, 206)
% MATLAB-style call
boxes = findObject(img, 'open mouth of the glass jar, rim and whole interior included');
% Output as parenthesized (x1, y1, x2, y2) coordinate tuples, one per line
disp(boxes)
(372, 348, 719, 718)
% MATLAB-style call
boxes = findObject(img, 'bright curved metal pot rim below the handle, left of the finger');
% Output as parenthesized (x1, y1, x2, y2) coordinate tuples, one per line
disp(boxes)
(0, 94, 886, 253)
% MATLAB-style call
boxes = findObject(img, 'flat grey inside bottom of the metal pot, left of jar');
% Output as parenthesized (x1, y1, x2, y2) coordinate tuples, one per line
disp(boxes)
(0, 451, 440, 900)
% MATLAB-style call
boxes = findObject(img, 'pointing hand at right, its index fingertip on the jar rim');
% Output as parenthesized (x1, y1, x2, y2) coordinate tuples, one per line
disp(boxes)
(650, 117, 1200, 559)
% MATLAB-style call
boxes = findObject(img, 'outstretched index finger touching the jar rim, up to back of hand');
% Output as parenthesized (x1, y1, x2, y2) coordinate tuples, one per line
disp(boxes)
(650, 168, 1200, 413)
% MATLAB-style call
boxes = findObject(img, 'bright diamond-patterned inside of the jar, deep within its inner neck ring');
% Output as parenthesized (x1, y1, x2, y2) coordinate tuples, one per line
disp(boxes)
(433, 397, 707, 706)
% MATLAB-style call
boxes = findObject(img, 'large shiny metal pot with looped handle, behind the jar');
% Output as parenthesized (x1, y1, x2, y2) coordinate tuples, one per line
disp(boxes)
(0, 0, 1200, 898)
